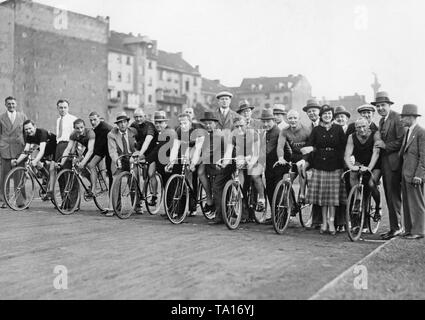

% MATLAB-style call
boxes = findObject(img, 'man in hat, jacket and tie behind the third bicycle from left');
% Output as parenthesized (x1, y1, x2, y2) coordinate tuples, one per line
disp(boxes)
(107, 112, 142, 216)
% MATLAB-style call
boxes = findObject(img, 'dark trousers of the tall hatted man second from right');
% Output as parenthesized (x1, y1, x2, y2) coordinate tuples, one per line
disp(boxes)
(382, 157, 401, 231)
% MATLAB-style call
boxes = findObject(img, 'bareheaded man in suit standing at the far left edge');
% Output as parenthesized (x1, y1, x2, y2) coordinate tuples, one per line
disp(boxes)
(0, 97, 28, 208)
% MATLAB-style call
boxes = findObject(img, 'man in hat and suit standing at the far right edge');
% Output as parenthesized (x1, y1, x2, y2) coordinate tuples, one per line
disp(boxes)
(400, 104, 425, 240)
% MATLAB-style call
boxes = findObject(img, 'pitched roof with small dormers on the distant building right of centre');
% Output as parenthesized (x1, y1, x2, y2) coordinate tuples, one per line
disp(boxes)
(239, 75, 303, 93)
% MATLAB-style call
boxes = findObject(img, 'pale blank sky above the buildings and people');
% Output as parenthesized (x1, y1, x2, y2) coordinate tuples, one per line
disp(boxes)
(35, 0, 425, 114)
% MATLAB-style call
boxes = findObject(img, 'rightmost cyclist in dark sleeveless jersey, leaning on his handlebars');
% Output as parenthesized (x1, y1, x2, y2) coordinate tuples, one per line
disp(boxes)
(344, 118, 381, 217)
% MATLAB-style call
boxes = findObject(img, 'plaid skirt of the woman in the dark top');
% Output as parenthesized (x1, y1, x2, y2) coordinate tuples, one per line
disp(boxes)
(306, 169, 347, 207)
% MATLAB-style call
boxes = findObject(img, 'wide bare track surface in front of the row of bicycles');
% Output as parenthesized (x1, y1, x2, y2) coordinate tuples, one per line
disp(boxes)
(0, 202, 381, 300)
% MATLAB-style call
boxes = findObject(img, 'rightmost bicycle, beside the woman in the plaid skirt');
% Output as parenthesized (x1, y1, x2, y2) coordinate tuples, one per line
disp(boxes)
(342, 169, 381, 242)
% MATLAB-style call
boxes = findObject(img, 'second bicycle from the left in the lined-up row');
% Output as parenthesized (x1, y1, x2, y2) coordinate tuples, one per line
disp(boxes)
(53, 154, 109, 215)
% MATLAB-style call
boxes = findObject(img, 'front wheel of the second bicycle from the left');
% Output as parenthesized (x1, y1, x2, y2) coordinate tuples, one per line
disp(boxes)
(53, 169, 81, 215)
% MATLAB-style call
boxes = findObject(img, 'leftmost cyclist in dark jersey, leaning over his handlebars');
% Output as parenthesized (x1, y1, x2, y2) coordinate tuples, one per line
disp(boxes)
(12, 120, 56, 200)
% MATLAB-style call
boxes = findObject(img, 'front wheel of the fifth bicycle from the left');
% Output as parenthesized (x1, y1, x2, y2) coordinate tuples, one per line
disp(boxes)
(222, 181, 242, 230)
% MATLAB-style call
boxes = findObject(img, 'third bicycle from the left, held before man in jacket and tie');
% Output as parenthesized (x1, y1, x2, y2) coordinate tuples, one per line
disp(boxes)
(111, 155, 164, 219)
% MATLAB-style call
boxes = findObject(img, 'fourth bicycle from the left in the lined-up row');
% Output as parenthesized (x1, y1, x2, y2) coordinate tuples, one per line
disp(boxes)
(164, 157, 215, 224)
